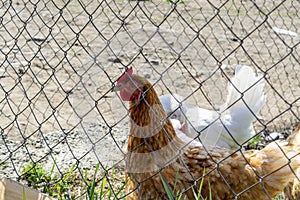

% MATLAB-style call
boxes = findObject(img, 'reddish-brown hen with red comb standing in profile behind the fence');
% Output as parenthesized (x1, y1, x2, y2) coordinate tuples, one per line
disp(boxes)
(114, 68, 300, 200)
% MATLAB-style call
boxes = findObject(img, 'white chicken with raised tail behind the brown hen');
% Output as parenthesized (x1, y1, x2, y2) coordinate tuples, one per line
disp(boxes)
(160, 65, 266, 149)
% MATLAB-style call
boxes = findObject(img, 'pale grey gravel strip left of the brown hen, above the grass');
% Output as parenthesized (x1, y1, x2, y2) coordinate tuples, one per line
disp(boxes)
(0, 124, 128, 179)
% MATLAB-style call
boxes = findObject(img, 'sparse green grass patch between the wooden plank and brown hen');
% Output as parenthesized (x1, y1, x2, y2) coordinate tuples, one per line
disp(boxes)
(22, 163, 126, 200)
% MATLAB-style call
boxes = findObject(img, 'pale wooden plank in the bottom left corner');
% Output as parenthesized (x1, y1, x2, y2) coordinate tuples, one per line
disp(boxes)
(0, 177, 54, 200)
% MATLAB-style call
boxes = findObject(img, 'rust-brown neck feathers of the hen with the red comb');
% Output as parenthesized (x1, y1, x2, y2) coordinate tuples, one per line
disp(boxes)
(127, 85, 176, 153)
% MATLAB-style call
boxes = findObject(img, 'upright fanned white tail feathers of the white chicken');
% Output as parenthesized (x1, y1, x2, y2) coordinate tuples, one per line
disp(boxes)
(224, 65, 266, 123)
